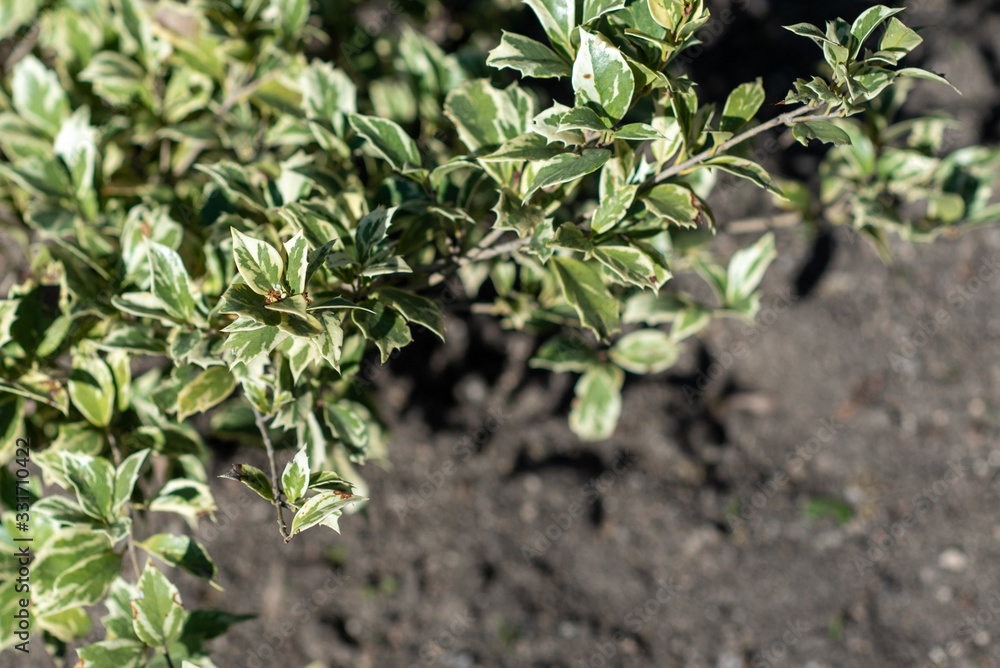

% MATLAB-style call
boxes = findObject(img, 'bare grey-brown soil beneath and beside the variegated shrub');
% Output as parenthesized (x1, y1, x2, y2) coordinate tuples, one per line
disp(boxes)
(7, 0, 1000, 668)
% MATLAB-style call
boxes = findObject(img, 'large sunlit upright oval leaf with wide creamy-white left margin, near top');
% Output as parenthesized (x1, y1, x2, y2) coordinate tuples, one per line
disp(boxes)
(573, 30, 635, 123)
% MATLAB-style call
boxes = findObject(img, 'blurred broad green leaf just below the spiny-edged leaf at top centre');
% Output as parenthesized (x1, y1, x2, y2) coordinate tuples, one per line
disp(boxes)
(444, 79, 535, 151)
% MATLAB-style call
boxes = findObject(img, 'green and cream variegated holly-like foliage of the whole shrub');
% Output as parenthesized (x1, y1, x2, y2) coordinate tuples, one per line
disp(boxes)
(0, 0, 1000, 667)
